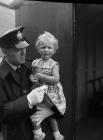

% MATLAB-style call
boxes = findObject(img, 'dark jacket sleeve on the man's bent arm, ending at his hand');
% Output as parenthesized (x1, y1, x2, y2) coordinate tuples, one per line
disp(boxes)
(0, 82, 36, 123)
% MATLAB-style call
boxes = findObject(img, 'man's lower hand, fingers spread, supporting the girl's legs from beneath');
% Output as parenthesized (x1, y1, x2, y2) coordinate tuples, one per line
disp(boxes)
(30, 106, 54, 125)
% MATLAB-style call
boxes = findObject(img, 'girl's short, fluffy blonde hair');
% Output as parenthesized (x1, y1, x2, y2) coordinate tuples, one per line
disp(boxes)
(35, 31, 58, 50)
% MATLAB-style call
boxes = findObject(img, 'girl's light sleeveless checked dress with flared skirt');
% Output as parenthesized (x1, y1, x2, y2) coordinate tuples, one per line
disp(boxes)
(32, 58, 66, 115)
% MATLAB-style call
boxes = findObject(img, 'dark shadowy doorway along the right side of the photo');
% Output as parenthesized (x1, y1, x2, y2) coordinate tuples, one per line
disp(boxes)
(75, 4, 103, 140)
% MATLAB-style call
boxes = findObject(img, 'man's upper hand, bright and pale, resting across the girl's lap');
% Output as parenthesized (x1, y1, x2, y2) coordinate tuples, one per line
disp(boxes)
(27, 85, 48, 106)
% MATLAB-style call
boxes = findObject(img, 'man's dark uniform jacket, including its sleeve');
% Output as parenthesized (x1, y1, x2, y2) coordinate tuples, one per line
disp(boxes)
(0, 60, 35, 140)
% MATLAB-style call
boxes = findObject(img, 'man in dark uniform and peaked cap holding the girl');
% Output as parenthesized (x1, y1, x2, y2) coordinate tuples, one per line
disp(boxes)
(0, 26, 54, 140)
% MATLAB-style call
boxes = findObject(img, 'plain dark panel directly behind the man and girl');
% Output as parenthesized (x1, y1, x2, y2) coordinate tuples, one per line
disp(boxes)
(16, 1, 73, 140)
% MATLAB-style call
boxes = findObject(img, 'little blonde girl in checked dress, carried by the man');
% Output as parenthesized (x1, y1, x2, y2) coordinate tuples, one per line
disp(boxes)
(30, 32, 66, 140)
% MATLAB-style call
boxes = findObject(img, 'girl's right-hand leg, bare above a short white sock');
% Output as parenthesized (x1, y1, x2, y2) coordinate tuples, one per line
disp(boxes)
(48, 117, 64, 140)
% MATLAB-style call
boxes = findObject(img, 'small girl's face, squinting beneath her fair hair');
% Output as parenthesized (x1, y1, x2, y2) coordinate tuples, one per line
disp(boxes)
(38, 44, 55, 60)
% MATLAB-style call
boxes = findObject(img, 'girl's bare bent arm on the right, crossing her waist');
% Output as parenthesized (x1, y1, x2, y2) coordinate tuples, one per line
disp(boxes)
(37, 65, 60, 84)
